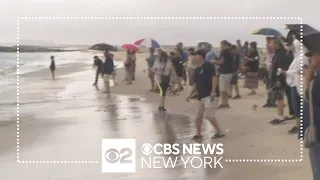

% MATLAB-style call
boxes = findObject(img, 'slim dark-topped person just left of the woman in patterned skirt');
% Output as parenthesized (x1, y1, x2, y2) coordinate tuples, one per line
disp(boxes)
(229, 45, 241, 99)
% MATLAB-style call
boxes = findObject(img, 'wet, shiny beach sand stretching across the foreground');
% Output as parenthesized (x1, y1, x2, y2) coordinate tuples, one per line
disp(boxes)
(0, 51, 311, 180)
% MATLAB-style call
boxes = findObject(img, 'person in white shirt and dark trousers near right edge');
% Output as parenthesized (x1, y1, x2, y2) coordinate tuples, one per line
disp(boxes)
(282, 35, 307, 134)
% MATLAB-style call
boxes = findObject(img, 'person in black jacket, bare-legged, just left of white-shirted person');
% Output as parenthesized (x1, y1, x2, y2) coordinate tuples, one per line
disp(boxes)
(270, 38, 290, 124)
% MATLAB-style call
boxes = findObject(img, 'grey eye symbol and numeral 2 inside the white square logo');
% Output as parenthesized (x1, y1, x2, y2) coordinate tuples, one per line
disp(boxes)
(105, 148, 132, 163)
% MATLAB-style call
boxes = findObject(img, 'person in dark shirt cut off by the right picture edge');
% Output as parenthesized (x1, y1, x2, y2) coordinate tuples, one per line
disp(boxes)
(299, 33, 320, 180)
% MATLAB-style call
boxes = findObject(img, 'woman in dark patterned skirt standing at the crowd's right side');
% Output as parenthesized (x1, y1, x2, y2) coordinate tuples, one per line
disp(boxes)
(244, 42, 260, 95)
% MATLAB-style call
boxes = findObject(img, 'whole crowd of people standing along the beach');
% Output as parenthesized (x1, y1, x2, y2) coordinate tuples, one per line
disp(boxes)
(50, 27, 320, 179)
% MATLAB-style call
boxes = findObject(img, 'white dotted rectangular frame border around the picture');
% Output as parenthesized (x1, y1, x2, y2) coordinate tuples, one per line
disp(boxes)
(17, 17, 304, 164)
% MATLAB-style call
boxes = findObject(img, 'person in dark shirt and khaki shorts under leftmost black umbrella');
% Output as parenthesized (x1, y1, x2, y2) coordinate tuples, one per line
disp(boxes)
(103, 52, 114, 93)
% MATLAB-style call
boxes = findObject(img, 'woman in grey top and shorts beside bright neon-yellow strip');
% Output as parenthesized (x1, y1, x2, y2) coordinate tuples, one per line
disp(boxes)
(152, 51, 173, 112)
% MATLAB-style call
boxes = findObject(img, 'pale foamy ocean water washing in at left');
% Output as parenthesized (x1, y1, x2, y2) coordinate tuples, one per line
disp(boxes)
(0, 51, 122, 124)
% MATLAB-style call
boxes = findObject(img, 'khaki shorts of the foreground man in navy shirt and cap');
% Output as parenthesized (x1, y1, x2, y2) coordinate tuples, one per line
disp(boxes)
(197, 96, 219, 120)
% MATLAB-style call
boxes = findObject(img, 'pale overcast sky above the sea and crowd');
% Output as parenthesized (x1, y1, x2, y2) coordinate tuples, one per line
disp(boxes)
(0, 0, 320, 45)
